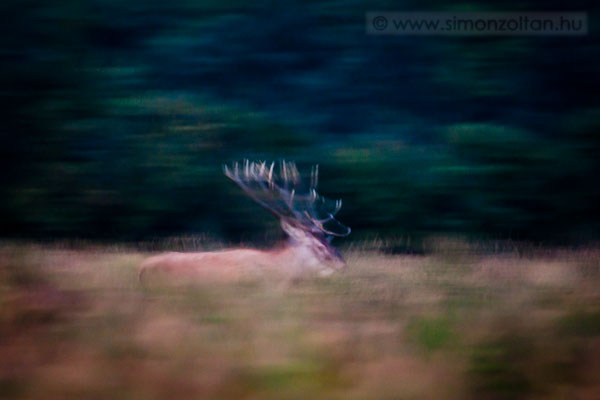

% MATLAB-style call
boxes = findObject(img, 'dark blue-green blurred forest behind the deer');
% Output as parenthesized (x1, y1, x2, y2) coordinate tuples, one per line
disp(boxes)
(0, 0, 600, 244)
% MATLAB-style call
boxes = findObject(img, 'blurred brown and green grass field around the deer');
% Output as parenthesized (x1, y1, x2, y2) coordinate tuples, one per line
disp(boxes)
(0, 241, 600, 400)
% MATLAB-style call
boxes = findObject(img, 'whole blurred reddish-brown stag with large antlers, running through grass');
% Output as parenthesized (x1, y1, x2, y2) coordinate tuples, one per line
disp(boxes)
(139, 162, 349, 282)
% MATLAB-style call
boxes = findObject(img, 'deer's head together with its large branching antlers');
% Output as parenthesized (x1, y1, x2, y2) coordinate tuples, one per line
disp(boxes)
(223, 160, 350, 275)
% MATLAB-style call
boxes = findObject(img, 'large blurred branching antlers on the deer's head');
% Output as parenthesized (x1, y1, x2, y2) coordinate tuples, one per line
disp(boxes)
(223, 160, 350, 236)
